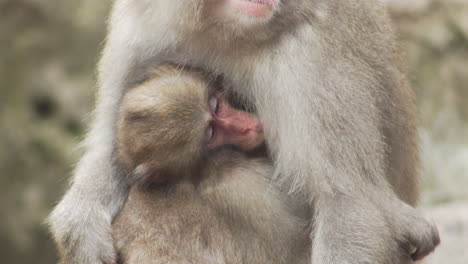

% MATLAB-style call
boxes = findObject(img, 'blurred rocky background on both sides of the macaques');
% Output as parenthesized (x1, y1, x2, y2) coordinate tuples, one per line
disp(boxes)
(0, 0, 468, 264)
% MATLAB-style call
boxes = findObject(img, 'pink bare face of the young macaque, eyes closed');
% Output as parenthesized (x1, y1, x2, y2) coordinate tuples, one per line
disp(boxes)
(208, 95, 264, 151)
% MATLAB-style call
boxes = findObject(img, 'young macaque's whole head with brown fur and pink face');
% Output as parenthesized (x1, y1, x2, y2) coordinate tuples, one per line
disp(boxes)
(117, 66, 263, 183)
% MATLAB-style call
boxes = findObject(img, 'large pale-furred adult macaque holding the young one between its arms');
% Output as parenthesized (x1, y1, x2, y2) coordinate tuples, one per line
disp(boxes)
(49, 0, 439, 264)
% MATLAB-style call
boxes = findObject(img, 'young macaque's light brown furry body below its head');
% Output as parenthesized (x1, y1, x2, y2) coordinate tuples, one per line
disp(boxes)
(113, 155, 310, 264)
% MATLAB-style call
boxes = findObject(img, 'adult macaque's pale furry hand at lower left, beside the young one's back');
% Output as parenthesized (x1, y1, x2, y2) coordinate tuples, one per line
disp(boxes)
(48, 200, 117, 264)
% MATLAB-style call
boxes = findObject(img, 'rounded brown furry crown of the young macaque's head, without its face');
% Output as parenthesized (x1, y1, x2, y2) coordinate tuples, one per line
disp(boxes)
(117, 65, 213, 185)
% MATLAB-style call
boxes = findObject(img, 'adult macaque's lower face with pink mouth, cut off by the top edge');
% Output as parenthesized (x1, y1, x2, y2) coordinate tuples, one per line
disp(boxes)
(151, 0, 282, 38)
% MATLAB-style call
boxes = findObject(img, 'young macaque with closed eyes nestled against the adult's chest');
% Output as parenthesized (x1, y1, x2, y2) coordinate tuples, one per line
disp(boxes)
(113, 66, 310, 264)
